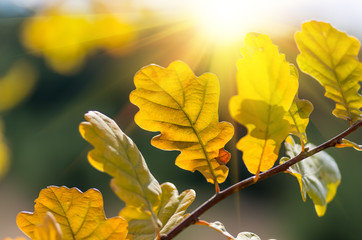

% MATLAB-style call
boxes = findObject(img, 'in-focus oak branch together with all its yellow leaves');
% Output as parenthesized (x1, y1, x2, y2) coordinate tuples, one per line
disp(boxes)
(6, 21, 362, 240)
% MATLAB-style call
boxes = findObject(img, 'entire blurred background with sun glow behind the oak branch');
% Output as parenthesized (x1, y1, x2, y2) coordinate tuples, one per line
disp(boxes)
(0, 0, 362, 240)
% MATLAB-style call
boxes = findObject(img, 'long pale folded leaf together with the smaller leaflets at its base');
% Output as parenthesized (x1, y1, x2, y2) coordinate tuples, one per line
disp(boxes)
(80, 112, 195, 240)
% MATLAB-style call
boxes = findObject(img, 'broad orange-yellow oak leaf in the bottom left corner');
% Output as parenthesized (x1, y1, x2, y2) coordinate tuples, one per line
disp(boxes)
(16, 186, 127, 240)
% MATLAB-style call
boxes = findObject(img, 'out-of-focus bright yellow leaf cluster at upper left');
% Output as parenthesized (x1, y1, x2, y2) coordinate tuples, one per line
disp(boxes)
(22, 1, 136, 74)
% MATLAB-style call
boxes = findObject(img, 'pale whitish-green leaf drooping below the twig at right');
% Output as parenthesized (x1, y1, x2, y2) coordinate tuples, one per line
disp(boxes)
(281, 137, 341, 217)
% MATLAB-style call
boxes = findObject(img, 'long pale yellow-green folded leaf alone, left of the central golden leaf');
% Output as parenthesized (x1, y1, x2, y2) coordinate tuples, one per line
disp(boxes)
(79, 111, 162, 223)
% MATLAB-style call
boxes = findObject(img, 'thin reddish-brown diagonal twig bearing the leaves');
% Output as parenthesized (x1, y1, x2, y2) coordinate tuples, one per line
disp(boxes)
(161, 121, 362, 240)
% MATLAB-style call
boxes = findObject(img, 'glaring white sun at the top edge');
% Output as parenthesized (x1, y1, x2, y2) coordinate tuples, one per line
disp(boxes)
(192, 0, 288, 43)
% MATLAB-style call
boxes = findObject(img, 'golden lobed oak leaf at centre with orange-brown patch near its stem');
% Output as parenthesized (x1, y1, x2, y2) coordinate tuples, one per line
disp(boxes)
(130, 61, 234, 183)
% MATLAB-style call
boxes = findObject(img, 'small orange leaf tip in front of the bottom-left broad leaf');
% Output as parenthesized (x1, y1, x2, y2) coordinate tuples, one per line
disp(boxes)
(34, 212, 63, 240)
